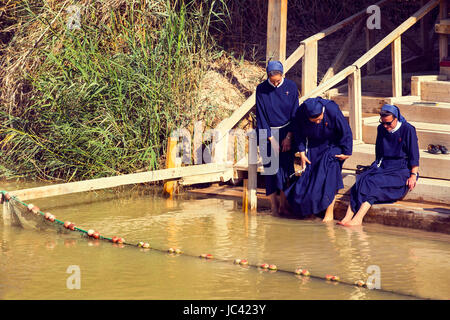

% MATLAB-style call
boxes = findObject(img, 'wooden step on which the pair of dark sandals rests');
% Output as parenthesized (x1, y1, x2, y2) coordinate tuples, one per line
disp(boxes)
(344, 143, 450, 180)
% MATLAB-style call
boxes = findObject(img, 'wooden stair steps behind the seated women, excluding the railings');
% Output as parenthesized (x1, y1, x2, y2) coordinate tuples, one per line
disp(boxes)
(330, 72, 450, 204)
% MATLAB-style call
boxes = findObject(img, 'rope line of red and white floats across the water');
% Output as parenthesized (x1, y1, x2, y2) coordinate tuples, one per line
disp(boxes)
(0, 191, 428, 299)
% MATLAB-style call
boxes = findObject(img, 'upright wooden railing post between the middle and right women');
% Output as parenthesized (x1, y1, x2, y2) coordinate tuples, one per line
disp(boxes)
(348, 69, 363, 142)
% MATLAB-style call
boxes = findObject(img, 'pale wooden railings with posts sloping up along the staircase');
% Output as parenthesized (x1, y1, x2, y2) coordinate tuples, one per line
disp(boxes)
(225, 0, 447, 211)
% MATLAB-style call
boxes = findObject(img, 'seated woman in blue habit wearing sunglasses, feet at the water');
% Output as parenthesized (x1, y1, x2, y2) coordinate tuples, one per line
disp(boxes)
(339, 104, 419, 226)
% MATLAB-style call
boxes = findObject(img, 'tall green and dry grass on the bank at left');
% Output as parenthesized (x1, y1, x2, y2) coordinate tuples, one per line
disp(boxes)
(0, 0, 226, 181)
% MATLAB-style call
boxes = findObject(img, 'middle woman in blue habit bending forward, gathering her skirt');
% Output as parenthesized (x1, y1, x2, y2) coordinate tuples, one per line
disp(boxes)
(285, 97, 353, 222)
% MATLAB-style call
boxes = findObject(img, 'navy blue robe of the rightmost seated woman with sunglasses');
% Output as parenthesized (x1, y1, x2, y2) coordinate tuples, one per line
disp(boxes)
(350, 120, 419, 213)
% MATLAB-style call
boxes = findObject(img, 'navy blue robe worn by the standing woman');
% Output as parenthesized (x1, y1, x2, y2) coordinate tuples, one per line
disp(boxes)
(256, 79, 299, 195)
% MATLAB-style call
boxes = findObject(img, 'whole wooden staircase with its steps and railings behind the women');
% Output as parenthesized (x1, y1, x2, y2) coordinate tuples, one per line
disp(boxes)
(211, 0, 450, 226)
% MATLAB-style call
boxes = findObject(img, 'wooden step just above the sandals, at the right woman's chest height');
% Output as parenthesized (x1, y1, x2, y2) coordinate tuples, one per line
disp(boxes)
(363, 116, 450, 149)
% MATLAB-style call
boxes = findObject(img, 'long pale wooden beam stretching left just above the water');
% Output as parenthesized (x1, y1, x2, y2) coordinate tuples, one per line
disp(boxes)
(9, 163, 228, 201)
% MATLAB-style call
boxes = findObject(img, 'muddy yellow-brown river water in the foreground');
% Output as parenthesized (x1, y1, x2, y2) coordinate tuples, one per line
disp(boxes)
(0, 182, 450, 300)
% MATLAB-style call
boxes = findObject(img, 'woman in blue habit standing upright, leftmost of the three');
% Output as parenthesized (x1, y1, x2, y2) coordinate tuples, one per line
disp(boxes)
(256, 61, 299, 214)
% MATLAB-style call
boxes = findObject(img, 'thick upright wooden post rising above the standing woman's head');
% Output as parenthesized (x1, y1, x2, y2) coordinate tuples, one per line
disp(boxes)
(266, 0, 287, 63)
